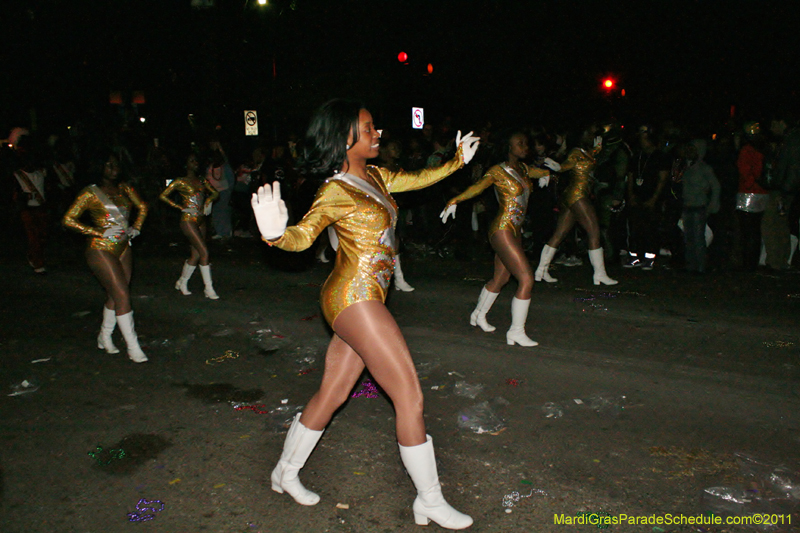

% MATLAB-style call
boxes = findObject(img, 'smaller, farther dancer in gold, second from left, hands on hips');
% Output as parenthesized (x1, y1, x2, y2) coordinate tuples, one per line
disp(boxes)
(158, 154, 219, 300)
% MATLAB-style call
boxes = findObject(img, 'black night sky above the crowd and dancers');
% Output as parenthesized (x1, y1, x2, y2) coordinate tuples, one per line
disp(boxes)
(0, 0, 800, 137)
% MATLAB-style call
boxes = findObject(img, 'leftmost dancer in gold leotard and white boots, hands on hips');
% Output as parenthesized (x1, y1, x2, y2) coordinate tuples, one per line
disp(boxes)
(62, 155, 147, 363)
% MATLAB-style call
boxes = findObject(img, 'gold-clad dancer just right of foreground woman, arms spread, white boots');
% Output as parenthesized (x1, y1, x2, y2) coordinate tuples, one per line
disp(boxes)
(441, 132, 550, 346)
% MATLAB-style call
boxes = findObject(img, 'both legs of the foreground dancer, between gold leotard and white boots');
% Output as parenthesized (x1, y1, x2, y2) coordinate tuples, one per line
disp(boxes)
(301, 301, 426, 446)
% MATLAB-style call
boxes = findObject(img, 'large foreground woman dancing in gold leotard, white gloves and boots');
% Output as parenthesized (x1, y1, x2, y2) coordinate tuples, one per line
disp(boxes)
(252, 100, 477, 529)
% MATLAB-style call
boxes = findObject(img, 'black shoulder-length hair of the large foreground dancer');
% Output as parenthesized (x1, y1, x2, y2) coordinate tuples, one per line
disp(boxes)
(303, 98, 365, 176)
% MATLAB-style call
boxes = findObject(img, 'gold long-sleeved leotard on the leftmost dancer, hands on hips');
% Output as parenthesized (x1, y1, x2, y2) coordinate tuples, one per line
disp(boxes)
(61, 183, 147, 257)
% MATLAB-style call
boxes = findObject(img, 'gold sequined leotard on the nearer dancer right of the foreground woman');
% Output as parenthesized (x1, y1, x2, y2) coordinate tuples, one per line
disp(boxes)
(447, 163, 550, 237)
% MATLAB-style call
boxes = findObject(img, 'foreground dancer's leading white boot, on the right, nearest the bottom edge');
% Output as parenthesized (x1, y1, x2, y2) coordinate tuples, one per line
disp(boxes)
(398, 435, 472, 529)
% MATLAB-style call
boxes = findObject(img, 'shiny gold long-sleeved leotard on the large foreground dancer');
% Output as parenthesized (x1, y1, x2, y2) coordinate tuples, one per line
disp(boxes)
(267, 148, 464, 326)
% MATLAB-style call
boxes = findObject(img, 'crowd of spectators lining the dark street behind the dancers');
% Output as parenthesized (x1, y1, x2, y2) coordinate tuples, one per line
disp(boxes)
(0, 110, 800, 273)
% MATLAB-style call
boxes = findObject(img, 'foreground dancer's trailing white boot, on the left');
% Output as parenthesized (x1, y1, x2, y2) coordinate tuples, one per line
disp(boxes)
(270, 413, 325, 505)
